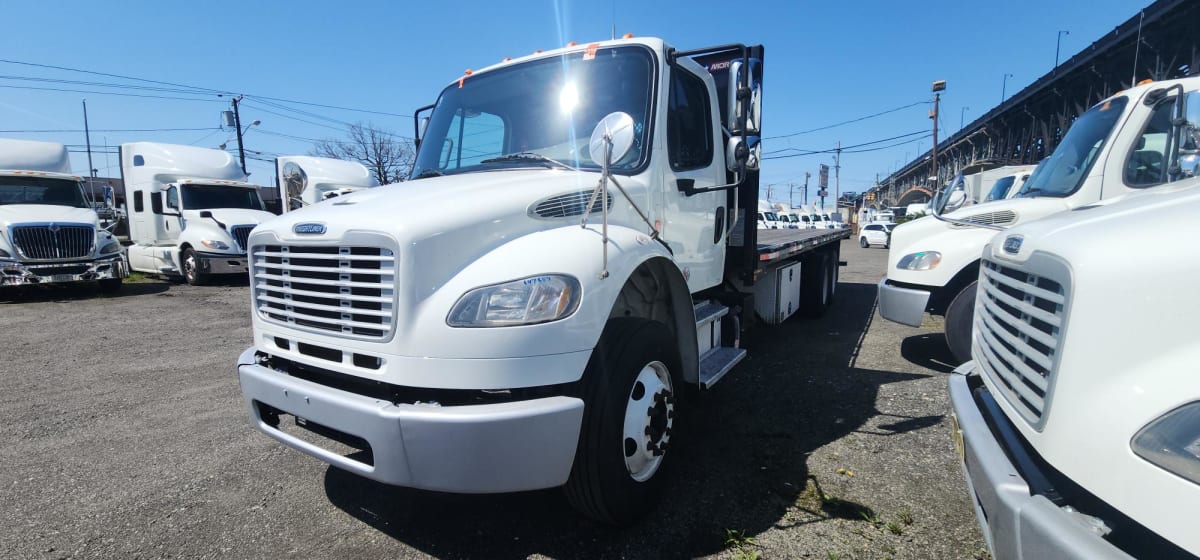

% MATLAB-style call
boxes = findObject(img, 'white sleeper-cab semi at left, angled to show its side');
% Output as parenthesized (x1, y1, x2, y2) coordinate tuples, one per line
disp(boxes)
(121, 141, 275, 285)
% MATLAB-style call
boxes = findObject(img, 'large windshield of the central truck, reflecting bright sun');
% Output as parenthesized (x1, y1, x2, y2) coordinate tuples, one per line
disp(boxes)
(413, 47, 655, 179)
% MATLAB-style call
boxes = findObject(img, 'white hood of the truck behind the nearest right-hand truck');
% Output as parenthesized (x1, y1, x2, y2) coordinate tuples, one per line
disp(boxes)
(888, 197, 1070, 285)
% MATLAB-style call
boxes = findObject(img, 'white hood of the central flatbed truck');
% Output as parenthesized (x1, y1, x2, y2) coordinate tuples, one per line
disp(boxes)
(251, 168, 628, 299)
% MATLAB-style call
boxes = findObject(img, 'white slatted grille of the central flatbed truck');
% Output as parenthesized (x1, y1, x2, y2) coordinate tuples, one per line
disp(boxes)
(251, 245, 396, 339)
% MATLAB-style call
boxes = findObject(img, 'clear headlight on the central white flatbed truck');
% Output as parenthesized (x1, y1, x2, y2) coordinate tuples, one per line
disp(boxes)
(446, 275, 580, 327)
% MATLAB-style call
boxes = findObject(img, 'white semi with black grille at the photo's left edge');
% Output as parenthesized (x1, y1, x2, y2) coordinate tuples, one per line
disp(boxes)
(0, 139, 127, 293)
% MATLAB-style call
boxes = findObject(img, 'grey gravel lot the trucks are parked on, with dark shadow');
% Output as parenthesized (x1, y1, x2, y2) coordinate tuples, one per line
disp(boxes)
(0, 240, 986, 559)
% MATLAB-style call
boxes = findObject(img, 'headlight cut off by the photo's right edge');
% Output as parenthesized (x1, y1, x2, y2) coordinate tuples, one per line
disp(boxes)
(1129, 402, 1200, 484)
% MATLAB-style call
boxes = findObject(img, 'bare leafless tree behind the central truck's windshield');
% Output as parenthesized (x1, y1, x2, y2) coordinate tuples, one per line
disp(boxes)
(312, 122, 416, 185)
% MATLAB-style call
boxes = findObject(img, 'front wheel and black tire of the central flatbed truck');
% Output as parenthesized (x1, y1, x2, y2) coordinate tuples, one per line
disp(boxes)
(564, 318, 683, 525)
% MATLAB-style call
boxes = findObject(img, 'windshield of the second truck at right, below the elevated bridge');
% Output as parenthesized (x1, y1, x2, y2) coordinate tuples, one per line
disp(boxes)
(1018, 96, 1129, 197)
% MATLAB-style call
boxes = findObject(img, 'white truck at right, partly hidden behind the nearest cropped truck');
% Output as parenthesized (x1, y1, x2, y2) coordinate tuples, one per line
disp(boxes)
(878, 77, 1200, 363)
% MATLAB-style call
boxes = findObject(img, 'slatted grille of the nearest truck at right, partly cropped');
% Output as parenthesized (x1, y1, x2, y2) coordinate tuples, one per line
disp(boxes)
(974, 259, 1067, 423)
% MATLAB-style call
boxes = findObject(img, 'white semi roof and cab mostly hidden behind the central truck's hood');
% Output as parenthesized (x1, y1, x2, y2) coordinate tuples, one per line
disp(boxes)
(275, 156, 379, 212)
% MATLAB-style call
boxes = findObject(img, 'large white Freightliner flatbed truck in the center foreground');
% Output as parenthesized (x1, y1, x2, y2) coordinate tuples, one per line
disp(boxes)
(236, 37, 846, 524)
